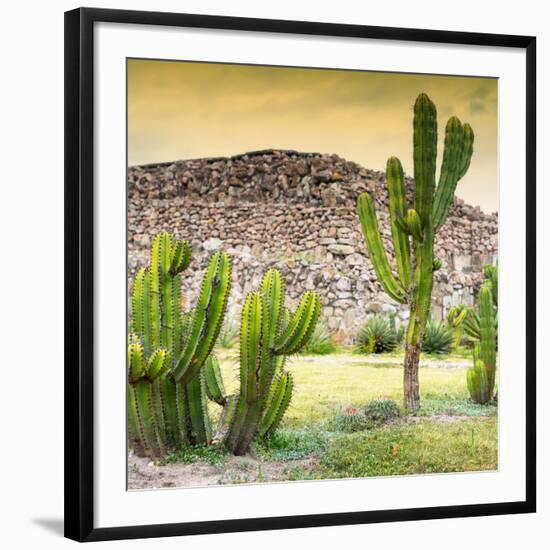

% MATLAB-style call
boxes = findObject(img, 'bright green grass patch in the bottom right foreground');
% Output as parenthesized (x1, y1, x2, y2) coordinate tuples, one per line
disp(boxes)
(317, 418, 497, 478)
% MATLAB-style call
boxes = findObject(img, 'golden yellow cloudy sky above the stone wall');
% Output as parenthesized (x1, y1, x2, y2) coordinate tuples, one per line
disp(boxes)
(128, 60, 498, 212)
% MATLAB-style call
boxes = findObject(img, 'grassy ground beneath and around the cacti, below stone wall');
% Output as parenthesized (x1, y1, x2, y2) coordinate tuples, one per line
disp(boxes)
(176, 350, 498, 483)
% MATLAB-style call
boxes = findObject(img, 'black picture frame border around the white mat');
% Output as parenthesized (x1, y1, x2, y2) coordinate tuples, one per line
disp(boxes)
(65, 8, 536, 542)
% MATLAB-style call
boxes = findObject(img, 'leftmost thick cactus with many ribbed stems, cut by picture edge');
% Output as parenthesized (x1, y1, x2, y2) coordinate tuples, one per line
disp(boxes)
(128, 232, 231, 456)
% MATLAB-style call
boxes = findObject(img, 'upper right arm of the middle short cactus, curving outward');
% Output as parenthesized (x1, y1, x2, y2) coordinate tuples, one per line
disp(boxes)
(273, 291, 321, 355)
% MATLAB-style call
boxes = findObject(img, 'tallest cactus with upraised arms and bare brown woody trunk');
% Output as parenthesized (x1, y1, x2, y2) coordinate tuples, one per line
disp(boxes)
(357, 94, 474, 410)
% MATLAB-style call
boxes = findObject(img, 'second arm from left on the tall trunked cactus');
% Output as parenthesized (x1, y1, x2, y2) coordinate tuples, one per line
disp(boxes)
(386, 157, 411, 288)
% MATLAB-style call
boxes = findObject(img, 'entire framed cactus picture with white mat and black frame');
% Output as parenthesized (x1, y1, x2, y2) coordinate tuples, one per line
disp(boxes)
(65, 8, 536, 541)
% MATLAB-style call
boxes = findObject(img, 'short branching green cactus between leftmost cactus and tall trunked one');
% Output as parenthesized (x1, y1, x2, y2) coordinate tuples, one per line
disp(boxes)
(225, 270, 321, 455)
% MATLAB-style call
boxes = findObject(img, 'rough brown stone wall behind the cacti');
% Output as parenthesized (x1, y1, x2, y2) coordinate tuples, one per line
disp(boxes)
(128, 150, 498, 342)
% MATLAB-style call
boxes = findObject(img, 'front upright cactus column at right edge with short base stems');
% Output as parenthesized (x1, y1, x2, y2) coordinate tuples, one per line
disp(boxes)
(467, 282, 497, 404)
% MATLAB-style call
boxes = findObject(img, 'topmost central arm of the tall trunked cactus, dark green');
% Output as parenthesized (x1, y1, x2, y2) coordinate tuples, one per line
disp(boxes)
(413, 94, 437, 226)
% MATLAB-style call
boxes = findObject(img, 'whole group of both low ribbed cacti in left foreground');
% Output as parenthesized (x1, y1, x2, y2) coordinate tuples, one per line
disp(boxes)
(128, 232, 321, 457)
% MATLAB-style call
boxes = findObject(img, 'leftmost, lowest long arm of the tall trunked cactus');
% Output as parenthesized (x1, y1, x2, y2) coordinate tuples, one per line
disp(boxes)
(357, 193, 406, 304)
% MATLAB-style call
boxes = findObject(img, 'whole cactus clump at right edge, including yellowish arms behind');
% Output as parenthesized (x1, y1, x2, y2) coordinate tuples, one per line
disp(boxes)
(464, 265, 498, 404)
